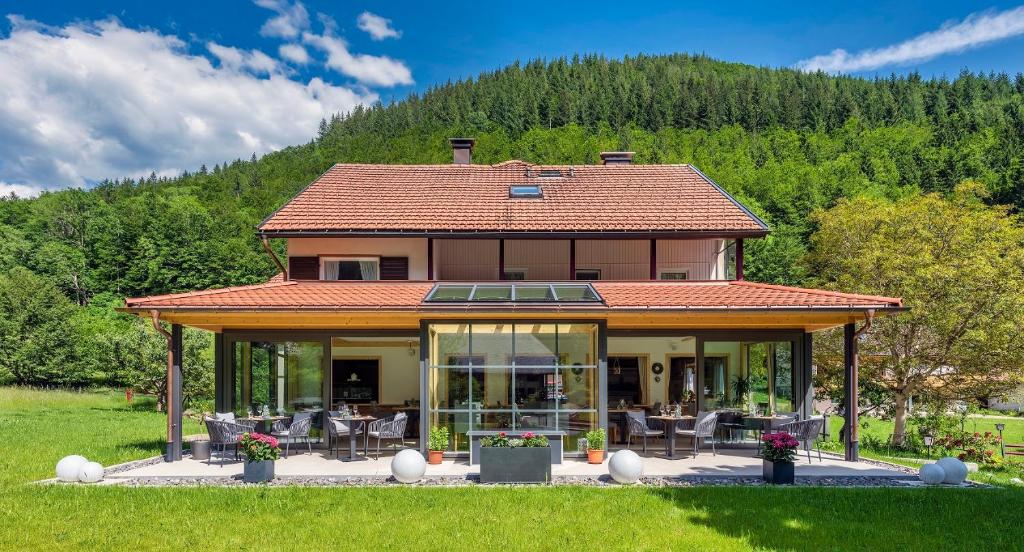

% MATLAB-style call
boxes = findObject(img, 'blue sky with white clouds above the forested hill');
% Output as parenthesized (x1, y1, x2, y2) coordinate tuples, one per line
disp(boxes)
(0, 0, 1024, 194)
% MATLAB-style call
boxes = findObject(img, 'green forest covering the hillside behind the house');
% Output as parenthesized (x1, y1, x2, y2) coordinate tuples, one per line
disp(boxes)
(0, 54, 1024, 396)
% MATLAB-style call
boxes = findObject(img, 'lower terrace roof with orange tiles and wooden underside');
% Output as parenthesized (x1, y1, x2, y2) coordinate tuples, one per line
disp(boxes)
(123, 281, 902, 331)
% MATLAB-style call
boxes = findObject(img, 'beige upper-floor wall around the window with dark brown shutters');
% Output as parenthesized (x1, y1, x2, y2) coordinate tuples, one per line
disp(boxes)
(288, 238, 427, 280)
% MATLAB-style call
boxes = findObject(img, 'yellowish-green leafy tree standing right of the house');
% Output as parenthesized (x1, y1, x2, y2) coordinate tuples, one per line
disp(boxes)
(808, 182, 1024, 443)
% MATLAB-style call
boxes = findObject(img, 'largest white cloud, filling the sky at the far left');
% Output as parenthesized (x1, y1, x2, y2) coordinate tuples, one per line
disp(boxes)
(0, 17, 377, 193)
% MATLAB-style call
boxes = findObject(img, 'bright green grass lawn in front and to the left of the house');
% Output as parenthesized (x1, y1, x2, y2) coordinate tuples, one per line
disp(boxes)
(0, 388, 1024, 550)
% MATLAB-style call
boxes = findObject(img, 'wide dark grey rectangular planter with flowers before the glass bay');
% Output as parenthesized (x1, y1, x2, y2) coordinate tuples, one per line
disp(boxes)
(480, 431, 551, 483)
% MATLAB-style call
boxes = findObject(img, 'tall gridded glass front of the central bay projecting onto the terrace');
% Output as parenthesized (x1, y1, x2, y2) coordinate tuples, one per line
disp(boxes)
(427, 323, 597, 451)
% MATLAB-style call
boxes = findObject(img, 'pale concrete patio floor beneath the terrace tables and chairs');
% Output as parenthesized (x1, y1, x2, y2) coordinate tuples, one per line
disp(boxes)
(106, 449, 906, 484)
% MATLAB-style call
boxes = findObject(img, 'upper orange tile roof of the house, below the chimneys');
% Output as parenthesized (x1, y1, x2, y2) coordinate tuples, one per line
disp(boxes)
(259, 161, 768, 236)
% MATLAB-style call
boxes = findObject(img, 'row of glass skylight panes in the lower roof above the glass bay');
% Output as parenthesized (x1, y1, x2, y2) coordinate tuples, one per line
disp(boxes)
(424, 282, 602, 303)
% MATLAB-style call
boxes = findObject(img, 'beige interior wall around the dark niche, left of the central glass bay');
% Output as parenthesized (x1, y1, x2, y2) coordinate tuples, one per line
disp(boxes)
(331, 339, 420, 405)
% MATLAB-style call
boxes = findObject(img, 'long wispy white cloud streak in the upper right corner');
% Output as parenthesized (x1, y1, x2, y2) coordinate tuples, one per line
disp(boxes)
(797, 6, 1024, 73)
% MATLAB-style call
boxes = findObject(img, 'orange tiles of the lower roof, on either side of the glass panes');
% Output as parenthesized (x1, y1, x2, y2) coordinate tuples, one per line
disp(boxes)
(125, 281, 902, 311)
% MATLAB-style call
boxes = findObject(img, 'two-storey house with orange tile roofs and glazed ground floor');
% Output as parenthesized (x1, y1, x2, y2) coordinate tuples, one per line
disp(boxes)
(124, 139, 902, 460)
